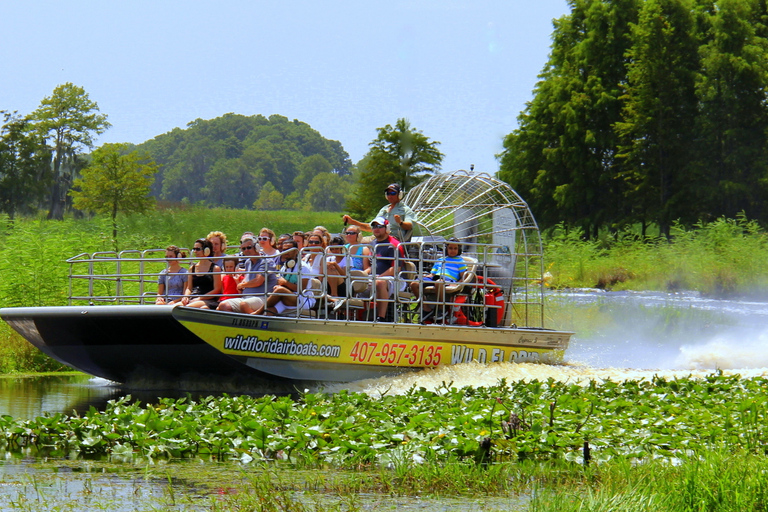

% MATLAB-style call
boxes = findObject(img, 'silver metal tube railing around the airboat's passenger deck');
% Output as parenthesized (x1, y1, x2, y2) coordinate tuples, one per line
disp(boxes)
(67, 240, 544, 327)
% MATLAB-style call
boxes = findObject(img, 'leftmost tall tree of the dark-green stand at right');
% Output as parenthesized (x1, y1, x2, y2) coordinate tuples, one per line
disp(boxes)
(499, 0, 638, 237)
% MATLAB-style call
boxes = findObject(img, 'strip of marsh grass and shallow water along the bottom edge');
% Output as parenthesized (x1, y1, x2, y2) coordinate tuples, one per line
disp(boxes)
(7, 450, 768, 512)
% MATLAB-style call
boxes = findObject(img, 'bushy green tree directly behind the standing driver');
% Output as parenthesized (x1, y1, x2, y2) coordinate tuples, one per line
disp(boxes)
(347, 118, 444, 217)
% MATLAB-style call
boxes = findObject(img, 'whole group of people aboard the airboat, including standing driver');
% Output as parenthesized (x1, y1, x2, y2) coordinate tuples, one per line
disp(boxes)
(156, 183, 456, 321)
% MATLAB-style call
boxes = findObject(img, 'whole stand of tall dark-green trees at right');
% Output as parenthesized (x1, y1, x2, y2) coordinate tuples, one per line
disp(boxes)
(499, 0, 768, 237)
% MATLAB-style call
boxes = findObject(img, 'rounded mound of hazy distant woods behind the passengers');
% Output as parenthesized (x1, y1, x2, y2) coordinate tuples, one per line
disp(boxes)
(138, 114, 351, 210)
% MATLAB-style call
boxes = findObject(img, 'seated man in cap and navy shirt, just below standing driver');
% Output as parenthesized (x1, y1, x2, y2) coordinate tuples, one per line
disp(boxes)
(365, 216, 405, 322)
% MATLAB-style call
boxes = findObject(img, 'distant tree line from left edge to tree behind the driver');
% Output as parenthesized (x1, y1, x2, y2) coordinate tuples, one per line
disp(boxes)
(0, 83, 442, 222)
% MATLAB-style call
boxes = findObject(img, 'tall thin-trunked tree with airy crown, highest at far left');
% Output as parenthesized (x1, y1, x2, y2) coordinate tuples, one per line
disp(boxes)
(29, 82, 110, 220)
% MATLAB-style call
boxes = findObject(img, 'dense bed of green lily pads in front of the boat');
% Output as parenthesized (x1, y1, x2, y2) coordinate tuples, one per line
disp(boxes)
(0, 375, 768, 467)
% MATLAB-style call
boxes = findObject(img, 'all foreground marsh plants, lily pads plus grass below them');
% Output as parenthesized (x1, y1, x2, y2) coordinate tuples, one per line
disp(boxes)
(0, 375, 768, 512)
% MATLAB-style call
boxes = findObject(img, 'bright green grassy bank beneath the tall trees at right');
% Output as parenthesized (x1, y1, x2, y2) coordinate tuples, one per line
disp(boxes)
(545, 218, 768, 296)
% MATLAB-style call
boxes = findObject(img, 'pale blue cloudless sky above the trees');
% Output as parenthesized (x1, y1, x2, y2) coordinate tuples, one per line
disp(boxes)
(0, 0, 569, 179)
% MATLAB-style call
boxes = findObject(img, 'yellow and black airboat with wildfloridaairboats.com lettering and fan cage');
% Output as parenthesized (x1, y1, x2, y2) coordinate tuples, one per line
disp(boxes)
(0, 171, 572, 389)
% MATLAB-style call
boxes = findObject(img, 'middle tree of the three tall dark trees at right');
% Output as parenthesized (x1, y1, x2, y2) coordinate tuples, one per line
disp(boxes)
(616, 0, 699, 236)
